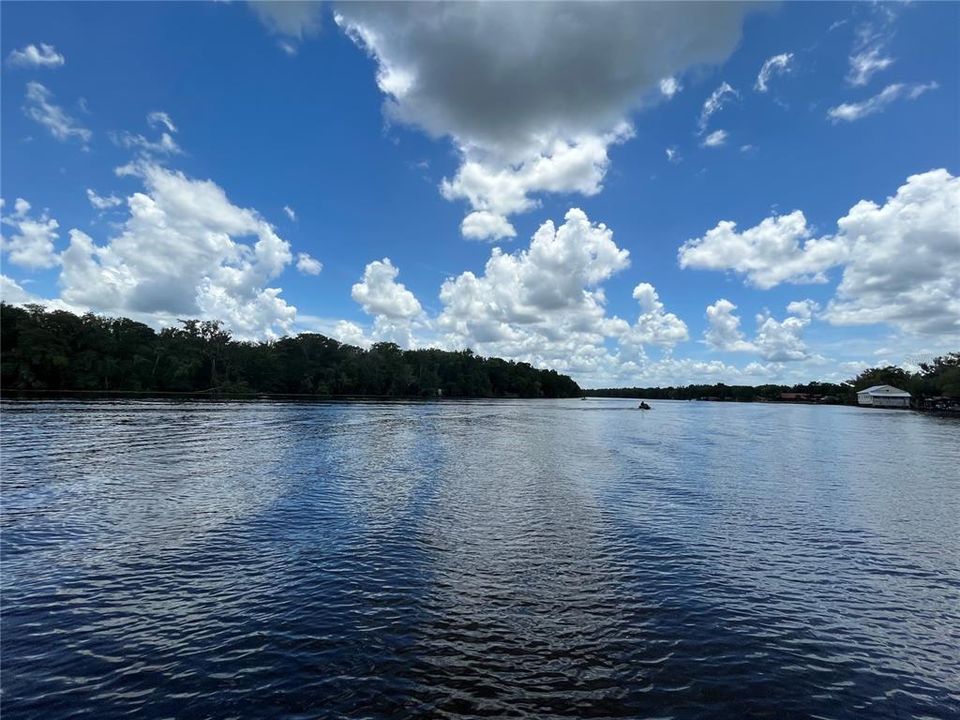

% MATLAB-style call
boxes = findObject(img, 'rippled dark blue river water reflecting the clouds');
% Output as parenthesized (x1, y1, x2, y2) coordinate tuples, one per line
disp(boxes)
(0, 400, 960, 720)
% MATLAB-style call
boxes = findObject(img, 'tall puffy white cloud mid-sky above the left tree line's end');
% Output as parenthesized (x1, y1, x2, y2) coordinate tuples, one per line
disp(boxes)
(435, 209, 632, 375)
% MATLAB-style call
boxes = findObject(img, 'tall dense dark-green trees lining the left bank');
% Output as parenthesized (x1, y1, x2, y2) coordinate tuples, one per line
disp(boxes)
(0, 304, 580, 397)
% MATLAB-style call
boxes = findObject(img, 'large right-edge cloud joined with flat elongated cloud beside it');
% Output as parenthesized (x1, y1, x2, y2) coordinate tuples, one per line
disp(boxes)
(679, 169, 960, 334)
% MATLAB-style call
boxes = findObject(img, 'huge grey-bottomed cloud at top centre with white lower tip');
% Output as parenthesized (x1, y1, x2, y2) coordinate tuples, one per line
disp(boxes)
(335, 3, 748, 239)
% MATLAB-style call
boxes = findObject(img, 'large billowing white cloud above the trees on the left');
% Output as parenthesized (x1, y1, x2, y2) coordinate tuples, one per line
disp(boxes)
(60, 162, 296, 339)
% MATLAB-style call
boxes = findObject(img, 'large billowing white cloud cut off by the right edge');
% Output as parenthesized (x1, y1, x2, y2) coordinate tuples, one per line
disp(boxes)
(825, 170, 960, 335)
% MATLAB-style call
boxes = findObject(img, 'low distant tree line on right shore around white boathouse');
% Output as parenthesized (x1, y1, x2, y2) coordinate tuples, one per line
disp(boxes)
(584, 352, 960, 404)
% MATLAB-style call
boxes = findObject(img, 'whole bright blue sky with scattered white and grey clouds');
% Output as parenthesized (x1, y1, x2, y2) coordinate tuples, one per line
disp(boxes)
(0, 2, 960, 387)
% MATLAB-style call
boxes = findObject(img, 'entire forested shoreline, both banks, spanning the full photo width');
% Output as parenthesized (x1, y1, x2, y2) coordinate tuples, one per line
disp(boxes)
(0, 303, 960, 415)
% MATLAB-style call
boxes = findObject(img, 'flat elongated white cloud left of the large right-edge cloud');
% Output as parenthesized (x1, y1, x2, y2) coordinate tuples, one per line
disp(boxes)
(678, 210, 847, 289)
